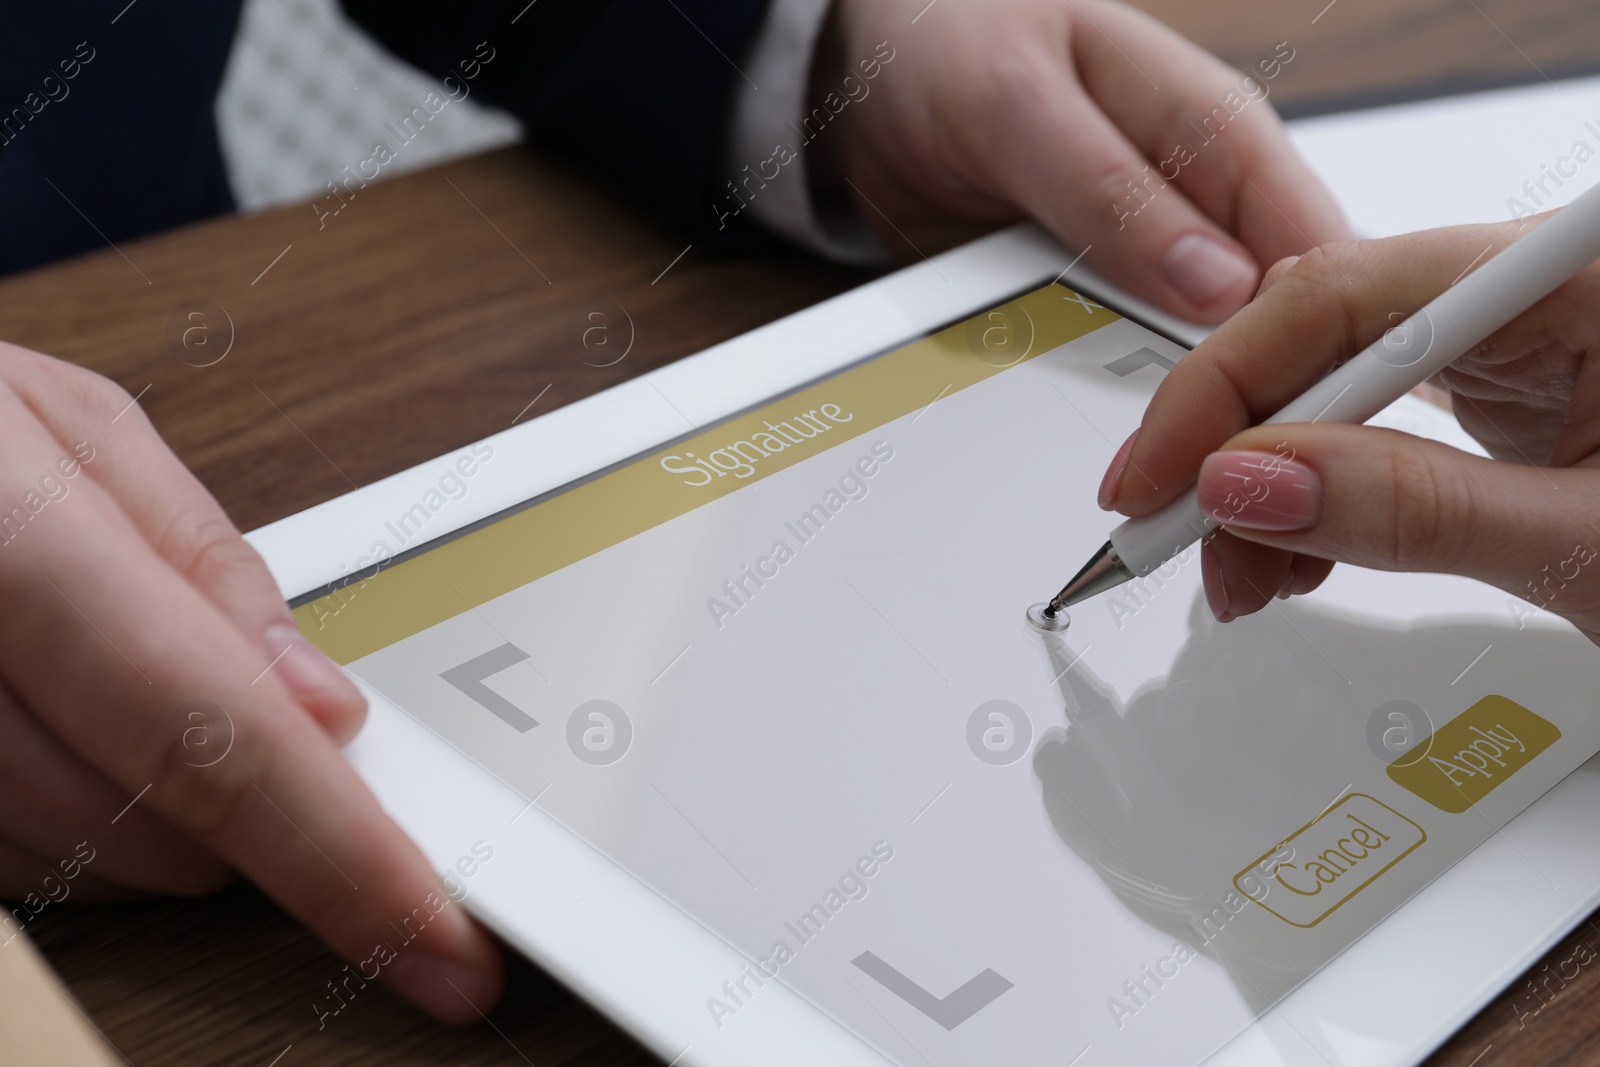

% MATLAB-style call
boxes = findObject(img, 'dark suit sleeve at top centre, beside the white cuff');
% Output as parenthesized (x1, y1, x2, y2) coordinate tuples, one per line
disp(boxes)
(341, 0, 766, 246)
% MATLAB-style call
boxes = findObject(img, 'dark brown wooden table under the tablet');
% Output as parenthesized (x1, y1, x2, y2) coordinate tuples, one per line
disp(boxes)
(0, 0, 1600, 1067)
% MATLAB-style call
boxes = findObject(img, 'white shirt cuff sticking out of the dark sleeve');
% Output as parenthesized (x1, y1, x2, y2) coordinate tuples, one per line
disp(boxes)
(718, 0, 888, 264)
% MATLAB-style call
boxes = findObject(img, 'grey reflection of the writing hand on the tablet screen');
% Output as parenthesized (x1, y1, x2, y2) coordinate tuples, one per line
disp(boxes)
(1034, 597, 1587, 1030)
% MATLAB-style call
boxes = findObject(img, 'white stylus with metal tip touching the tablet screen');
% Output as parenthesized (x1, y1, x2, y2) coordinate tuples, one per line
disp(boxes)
(1035, 186, 1600, 622)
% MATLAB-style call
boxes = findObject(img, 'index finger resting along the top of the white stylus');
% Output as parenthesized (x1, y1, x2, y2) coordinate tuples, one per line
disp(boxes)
(1109, 224, 1517, 515)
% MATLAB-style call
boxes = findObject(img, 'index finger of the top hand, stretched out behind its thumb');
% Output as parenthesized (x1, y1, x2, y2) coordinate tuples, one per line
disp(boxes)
(1074, 2, 1350, 267)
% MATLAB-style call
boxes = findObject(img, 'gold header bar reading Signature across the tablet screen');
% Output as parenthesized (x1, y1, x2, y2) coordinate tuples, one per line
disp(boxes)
(294, 285, 1118, 664)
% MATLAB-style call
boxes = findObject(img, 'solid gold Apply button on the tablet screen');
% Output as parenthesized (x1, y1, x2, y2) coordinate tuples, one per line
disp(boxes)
(1389, 696, 1562, 814)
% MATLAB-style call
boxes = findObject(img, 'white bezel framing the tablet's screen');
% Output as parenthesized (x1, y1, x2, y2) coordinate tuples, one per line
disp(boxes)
(246, 224, 1600, 1067)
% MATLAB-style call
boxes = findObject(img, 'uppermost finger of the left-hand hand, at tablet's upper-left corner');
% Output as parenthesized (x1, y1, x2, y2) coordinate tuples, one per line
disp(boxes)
(0, 344, 366, 742)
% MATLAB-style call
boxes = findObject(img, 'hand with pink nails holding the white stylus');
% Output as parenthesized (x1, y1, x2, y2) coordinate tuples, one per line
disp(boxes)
(1101, 216, 1600, 643)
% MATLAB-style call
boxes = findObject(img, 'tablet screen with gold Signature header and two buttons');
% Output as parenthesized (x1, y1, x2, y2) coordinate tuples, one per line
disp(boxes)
(296, 285, 1600, 1067)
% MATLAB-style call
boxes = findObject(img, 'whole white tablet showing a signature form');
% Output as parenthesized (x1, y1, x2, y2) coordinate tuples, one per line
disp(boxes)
(250, 226, 1600, 1067)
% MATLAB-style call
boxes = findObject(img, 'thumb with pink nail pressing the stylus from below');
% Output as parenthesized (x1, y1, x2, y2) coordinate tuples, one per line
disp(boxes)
(1198, 424, 1600, 607)
